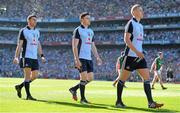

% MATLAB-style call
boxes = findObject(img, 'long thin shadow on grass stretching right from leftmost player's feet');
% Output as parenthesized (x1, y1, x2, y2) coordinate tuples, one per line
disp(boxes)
(36, 100, 123, 111)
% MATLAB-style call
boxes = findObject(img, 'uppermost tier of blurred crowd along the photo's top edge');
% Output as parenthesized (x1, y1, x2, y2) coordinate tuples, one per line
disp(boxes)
(0, 0, 180, 19)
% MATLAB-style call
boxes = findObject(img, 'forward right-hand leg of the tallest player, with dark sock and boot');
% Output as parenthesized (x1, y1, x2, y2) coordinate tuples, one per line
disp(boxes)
(137, 68, 163, 108)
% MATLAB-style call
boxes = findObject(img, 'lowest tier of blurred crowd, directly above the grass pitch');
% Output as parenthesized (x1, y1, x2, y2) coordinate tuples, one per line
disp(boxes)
(0, 46, 180, 81)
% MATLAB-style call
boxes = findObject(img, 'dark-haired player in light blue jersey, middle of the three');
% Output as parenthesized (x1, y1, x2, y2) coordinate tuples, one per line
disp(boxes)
(69, 12, 102, 104)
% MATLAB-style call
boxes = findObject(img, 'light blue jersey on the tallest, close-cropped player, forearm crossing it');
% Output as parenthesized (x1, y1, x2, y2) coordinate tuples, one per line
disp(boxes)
(125, 18, 144, 57)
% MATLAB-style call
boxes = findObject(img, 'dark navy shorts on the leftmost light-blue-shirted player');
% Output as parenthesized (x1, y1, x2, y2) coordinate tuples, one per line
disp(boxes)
(19, 58, 39, 71)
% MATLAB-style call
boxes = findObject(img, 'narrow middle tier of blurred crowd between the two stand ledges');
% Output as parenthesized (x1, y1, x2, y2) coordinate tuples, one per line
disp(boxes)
(0, 30, 180, 44)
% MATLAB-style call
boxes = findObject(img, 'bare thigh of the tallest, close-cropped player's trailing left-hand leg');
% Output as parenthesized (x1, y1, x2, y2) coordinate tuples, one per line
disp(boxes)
(119, 69, 131, 81)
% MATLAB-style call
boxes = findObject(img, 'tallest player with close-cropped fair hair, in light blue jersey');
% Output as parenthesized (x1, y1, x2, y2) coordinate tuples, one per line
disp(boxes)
(116, 4, 163, 108)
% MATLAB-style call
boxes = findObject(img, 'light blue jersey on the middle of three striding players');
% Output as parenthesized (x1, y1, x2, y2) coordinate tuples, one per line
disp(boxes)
(73, 25, 94, 60)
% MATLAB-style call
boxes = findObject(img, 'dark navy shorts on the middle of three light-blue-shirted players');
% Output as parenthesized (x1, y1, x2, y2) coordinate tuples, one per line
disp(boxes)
(79, 59, 93, 73)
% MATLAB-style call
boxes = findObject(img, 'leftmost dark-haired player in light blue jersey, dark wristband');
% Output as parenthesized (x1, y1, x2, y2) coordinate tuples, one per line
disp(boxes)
(13, 15, 46, 100)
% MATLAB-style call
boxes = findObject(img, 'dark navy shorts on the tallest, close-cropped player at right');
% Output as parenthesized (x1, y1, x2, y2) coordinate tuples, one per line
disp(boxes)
(122, 56, 147, 71)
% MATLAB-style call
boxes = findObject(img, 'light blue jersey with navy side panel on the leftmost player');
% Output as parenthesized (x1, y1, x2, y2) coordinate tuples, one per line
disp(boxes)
(18, 26, 40, 59)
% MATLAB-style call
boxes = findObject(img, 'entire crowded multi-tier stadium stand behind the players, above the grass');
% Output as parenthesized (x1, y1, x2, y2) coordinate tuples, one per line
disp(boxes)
(0, 0, 180, 81)
